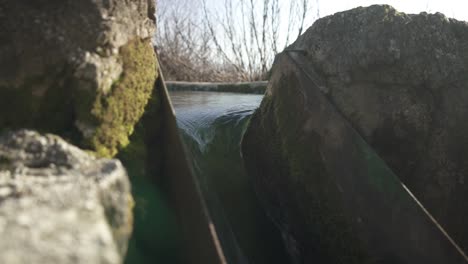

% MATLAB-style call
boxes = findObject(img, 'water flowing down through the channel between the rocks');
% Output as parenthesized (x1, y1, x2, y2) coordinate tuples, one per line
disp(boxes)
(170, 91, 288, 264)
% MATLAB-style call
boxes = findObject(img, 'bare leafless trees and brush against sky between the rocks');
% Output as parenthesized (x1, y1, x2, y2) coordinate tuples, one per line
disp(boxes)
(156, 0, 319, 81)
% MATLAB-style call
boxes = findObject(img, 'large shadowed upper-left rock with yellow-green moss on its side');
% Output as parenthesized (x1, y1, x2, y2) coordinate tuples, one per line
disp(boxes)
(0, 0, 157, 156)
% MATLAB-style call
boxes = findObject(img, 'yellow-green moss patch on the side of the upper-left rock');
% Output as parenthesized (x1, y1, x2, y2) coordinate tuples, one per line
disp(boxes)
(76, 39, 157, 157)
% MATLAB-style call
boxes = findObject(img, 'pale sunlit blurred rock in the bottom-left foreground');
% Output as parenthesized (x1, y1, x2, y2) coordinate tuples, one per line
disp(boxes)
(0, 130, 133, 263)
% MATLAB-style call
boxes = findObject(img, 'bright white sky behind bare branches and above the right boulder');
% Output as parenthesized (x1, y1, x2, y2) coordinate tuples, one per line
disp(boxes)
(158, 0, 468, 71)
